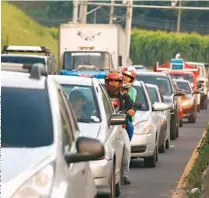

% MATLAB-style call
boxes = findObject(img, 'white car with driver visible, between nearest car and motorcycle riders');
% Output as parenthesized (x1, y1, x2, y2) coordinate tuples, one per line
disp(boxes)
(51, 75, 126, 197)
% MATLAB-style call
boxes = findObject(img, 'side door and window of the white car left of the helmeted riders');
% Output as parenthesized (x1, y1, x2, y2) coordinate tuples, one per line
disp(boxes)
(99, 85, 124, 181)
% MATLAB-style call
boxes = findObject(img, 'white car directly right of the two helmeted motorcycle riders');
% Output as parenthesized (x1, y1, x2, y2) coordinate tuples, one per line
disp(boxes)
(131, 81, 169, 167)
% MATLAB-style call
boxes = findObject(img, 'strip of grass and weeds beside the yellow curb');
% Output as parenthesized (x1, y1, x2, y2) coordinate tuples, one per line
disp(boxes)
(186, 123, 209, 198)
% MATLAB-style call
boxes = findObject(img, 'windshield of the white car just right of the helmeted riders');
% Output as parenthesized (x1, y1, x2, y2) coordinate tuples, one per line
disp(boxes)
(134, 86, 149, 111)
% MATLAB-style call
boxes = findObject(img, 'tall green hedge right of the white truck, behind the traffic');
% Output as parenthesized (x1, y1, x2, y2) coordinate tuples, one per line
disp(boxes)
(131, 29, 209, 67)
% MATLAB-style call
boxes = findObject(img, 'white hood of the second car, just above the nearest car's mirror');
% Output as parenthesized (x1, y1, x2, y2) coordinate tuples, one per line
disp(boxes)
(78, 122, 101, 138)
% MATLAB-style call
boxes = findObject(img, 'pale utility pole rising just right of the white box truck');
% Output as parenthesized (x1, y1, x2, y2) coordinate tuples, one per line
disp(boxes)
(125, 0, 133, 67)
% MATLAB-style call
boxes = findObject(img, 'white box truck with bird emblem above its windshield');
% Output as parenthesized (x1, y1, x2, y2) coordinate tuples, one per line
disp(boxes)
(59, 23, 126, 71)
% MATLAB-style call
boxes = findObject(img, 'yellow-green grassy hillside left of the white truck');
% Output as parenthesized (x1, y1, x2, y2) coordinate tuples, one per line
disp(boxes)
(1, 2, 58, 57)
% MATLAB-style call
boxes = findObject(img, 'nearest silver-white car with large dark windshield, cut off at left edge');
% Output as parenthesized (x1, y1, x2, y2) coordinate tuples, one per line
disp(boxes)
(1, 65, 105, 198)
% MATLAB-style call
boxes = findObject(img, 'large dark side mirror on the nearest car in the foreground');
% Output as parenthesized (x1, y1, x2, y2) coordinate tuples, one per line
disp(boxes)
(65, 137, 105, 164)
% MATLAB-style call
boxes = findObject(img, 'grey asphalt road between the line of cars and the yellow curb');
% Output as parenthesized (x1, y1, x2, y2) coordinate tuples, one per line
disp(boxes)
(120, 107, 209, 198)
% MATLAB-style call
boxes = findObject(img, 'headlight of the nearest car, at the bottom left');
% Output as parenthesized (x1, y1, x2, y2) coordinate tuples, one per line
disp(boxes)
(12, 164, 54, 198)
